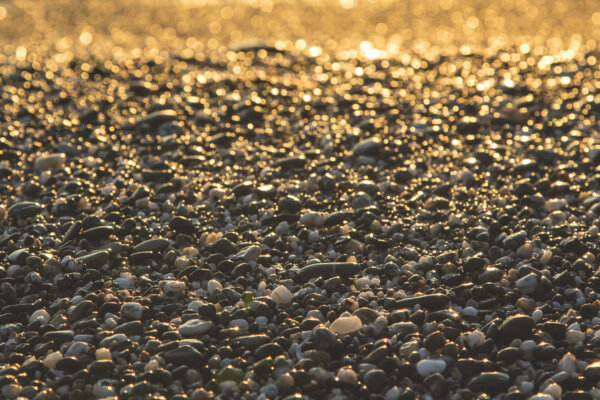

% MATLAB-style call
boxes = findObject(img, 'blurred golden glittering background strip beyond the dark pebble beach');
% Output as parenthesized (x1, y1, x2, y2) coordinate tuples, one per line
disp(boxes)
(0, 0, 600, 55)
